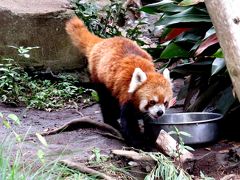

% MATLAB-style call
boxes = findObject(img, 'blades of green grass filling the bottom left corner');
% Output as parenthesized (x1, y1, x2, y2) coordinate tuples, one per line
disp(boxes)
(0, 136, 97, 180)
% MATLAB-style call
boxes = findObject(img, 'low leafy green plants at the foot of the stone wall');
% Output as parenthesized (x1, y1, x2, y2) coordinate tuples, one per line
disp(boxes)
(0, 46, 98, 110)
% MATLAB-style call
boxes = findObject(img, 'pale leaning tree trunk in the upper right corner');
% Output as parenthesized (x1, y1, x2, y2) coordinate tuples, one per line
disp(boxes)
(205, 0, 240, 100)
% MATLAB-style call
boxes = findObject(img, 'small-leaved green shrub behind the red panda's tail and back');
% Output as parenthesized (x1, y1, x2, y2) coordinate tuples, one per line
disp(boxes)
(73, 0, 146, 45)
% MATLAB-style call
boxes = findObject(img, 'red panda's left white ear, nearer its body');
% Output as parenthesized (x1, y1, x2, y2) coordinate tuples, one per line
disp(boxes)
(128, 68, 147, 93)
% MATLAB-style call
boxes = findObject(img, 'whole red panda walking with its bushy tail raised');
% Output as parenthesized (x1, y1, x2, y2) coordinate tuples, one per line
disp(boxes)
(66, 17, 173, 147)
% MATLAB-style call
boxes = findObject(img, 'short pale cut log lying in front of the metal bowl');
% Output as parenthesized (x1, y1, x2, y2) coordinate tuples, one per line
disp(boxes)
(156, 130, 194, 163)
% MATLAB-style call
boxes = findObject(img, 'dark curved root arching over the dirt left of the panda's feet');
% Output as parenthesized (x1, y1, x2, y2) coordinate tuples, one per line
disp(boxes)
(41, 116, 122, 138)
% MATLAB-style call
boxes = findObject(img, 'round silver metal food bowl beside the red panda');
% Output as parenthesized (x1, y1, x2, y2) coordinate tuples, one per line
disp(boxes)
(145, 112, 223, 145)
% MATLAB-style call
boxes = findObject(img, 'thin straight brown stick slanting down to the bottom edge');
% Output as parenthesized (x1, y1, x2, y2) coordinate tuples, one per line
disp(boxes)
(59, 160, 115, 180)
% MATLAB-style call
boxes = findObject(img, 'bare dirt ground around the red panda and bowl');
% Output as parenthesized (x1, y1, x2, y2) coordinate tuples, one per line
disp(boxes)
(0, 80, 240, 180)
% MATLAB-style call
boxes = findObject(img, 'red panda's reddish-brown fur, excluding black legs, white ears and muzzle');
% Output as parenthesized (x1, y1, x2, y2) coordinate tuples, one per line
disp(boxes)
(66, 17, 172, 106)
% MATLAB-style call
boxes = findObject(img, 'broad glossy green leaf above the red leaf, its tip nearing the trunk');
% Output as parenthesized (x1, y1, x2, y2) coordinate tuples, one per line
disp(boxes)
(156, 7, 211, 27)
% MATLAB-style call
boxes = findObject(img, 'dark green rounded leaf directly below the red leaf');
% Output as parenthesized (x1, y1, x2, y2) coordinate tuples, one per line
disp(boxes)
(160, 42, 189, 59)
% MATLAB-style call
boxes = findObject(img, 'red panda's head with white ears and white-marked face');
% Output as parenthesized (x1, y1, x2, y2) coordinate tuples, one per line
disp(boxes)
(128, 68, 173, 119)
